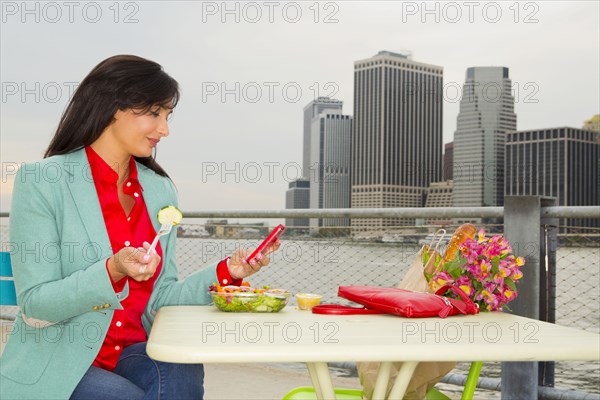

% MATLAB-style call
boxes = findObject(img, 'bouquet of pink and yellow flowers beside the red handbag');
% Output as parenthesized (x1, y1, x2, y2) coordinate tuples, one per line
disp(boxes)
(424, 224, 525, 311)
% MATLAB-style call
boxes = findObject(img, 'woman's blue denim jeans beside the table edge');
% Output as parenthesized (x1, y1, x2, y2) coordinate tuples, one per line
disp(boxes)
(71, 342, 204, 400)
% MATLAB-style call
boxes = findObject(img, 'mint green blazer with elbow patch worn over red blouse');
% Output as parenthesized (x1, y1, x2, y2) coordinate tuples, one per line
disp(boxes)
(0, 149, 217, 400)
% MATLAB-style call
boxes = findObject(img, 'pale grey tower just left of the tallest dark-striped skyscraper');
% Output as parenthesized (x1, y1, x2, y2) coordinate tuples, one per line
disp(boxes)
(310, 109, 352, 228)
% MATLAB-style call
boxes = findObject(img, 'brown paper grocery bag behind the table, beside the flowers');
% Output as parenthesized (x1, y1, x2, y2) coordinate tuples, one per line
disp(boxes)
(356, 229, 456, 400)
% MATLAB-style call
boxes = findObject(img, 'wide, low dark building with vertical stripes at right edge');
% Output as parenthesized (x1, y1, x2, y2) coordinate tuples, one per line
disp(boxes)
(505, 127, 600, 232)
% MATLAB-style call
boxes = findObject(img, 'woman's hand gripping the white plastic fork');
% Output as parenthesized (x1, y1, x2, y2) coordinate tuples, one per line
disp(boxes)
(108, 242, 160, 282)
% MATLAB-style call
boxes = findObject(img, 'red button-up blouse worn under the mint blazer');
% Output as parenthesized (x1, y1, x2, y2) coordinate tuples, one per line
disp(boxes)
(85, 146, 242, 371)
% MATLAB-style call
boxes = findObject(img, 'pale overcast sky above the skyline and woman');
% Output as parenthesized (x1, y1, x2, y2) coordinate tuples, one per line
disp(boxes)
(0, 1, 600, 216)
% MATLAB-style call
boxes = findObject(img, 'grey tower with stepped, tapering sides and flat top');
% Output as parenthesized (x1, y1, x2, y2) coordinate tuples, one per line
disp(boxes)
(453, 67, 517, 216)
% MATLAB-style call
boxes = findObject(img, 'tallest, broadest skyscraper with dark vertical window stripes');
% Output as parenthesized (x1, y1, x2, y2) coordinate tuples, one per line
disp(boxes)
(352, 51, 443, 231)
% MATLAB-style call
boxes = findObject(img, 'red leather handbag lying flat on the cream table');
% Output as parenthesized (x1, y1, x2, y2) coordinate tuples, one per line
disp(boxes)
(313, 285, 479, 318)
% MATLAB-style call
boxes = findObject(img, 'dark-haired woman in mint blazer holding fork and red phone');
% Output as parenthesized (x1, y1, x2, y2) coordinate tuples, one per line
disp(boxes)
(0, 55, 279, 399)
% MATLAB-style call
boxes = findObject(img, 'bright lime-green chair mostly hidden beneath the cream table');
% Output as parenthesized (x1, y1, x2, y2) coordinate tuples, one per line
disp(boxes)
(283, 361, 483, 400)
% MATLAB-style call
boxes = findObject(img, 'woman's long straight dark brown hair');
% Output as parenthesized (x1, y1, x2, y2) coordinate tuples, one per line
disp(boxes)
(44, 55, 179, 177)
